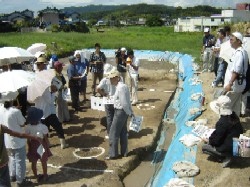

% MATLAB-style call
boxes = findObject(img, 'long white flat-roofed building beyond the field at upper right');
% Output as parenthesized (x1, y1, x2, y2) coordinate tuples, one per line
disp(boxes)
(174, 10, 250, 32)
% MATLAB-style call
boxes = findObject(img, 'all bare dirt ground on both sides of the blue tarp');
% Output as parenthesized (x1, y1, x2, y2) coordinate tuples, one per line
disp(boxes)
(13, 59, 250, 187)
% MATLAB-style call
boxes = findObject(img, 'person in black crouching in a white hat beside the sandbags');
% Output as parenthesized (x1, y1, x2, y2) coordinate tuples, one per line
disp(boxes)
(202, 95, 243, 167)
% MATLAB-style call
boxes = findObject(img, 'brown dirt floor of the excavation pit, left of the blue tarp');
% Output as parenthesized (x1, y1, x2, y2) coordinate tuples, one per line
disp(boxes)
(17, 59, 176, 187)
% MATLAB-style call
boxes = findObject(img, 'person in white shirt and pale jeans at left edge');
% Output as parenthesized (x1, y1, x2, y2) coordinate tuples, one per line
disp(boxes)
(1, 101, 28, 186)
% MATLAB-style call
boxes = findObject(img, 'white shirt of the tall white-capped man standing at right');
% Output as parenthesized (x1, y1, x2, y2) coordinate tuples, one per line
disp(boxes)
(224, 47, 248, 93)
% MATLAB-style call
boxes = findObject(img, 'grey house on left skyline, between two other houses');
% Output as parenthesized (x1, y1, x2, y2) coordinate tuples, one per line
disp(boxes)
(38, 7, 60, 26)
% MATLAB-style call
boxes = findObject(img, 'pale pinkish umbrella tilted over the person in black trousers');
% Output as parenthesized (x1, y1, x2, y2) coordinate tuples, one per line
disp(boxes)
(27, 70, 55, 102)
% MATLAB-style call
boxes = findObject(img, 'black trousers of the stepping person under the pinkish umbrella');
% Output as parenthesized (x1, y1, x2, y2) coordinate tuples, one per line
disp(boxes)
(42, 114, 64, 139)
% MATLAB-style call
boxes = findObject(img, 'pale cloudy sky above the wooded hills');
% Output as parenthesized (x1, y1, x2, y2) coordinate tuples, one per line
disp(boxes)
(0, 0, 248, 13)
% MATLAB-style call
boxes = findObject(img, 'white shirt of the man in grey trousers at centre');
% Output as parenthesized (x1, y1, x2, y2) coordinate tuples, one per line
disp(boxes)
(114, 82, 133, 116)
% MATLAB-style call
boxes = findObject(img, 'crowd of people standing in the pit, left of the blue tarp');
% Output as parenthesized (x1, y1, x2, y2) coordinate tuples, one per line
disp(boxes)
(0, 43, 139, 187)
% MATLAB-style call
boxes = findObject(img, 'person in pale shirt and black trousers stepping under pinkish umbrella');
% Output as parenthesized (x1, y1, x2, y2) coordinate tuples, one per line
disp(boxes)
(34, 81, 69, 149)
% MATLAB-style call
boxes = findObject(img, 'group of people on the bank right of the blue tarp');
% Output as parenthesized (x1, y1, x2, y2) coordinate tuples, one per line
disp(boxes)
(202, 26, 250, 166)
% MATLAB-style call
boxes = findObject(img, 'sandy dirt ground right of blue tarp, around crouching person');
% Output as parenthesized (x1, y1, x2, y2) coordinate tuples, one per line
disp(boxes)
(194, 73, 250, 187)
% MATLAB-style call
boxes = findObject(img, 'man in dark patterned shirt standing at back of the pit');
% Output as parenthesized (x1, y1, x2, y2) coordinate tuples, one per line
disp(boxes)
(89, 43, 106, 96)
